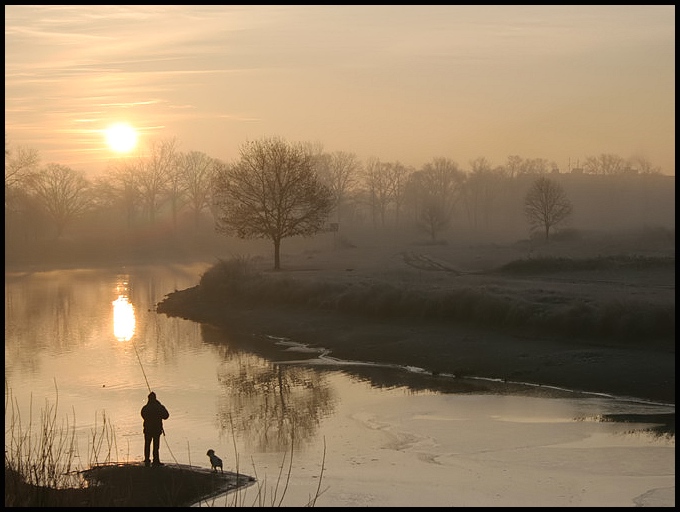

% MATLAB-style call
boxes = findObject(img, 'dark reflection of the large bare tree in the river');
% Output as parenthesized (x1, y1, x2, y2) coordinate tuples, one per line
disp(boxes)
(201, 325, 337, 452)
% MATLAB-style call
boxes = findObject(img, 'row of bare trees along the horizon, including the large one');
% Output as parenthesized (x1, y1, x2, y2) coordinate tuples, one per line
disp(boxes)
(5, 137, 672, 268)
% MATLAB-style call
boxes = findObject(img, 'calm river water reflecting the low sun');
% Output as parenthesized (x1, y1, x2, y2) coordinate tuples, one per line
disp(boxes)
(5, 264, 675, 506)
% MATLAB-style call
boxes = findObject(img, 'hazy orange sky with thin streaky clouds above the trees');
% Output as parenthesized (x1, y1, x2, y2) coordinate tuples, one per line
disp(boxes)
(5, 5, 675, 174)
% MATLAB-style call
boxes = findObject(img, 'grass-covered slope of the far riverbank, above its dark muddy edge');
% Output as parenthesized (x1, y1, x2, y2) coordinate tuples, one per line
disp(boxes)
(167, 256, 675, 346)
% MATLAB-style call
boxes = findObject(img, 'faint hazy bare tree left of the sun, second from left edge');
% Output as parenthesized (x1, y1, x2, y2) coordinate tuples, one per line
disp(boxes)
(31, 164, 91, 238)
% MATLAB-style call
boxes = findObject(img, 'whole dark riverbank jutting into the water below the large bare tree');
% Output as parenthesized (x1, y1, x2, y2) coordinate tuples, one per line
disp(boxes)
(157, 241, 675, 404)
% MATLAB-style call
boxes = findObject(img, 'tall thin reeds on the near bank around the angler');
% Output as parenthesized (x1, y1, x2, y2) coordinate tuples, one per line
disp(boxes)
(5, 380, 325, 507)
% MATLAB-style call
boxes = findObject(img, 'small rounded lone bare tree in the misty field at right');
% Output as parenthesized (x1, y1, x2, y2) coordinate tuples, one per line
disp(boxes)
(524, 176, 572, 240)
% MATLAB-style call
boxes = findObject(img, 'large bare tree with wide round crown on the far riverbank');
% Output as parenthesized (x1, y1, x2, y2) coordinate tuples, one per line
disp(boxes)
(214, 138, 333, 270)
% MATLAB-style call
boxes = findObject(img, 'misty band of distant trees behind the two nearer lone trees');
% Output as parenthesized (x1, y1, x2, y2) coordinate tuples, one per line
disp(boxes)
(5, 135, 675, 272)
